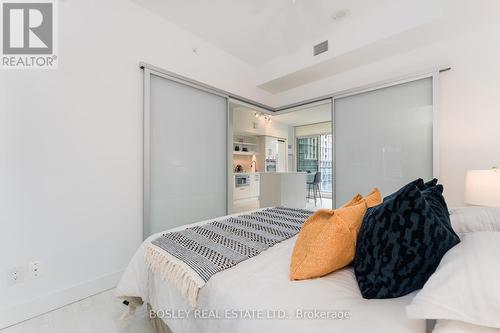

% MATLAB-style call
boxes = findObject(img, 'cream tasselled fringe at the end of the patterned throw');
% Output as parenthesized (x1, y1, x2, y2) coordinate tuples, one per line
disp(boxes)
(145, 244, 205, 307)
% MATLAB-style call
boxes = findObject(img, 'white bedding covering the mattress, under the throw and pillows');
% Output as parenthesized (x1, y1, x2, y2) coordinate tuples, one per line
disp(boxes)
(116, 213, 425, 333)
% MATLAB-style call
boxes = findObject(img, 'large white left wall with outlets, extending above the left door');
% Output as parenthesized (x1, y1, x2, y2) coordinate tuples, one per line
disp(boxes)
(0, 0, 269, 327)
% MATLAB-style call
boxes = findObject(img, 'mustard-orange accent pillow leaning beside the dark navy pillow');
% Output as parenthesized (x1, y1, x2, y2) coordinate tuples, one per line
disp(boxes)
(290, 189, 382, 280)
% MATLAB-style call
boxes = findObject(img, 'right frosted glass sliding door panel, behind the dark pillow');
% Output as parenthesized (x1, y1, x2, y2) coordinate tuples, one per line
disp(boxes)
(334, 78, 433, 207)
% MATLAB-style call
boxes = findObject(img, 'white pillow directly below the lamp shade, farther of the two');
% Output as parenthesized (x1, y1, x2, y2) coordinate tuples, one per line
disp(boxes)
(450, 206, 500, 234)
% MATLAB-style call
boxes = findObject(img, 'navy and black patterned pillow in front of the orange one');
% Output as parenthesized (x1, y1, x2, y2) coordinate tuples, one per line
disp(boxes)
(354, 182, 460, 298)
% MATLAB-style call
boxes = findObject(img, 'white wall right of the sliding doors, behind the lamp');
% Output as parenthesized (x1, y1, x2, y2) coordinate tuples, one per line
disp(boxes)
(439, 20, 500, 206)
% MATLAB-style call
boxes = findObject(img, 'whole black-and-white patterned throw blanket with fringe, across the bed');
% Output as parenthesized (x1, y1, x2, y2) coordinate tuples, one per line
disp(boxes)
(145, 207, 313, 307)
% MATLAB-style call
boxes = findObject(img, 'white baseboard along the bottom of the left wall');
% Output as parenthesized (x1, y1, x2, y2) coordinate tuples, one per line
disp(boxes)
(0, 271, 123, 330)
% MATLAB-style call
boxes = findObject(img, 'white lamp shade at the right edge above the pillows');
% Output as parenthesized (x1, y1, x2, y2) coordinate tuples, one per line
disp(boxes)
(465, 169, 500, 207)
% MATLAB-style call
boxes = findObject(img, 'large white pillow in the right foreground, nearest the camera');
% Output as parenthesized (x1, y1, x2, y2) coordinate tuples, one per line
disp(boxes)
(406, 232, 500, 328)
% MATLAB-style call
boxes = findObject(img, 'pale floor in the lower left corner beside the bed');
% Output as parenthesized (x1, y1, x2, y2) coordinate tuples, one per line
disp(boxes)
(0, 289, 154, 333)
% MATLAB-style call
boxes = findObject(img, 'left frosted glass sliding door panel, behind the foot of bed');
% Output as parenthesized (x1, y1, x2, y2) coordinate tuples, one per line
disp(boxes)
(144, 71, 227, 237)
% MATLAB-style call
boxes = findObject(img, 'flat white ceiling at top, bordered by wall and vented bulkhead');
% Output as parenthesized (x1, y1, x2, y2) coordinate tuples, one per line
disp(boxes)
(134, 0, 394, 66)
